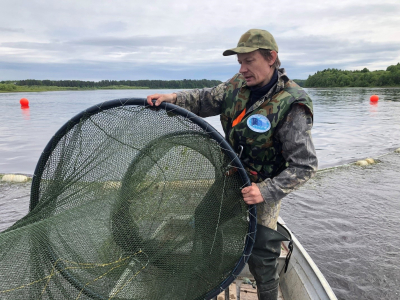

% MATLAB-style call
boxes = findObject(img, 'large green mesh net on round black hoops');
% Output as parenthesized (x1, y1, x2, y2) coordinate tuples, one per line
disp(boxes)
(0, 99, 256, 300)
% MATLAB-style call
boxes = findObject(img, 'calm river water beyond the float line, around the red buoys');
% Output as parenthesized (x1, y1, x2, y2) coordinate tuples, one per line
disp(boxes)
(0, 88, 400, 174)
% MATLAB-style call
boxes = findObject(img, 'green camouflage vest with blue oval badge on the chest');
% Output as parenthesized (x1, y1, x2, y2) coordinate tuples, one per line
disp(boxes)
(220, 74, 313, 182)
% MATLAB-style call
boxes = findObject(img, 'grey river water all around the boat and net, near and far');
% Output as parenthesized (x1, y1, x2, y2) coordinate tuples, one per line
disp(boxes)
(0, 88, 400, 299)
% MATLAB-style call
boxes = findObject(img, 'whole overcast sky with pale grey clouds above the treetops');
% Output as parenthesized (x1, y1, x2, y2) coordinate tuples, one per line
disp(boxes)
(0, 0, 400, 80)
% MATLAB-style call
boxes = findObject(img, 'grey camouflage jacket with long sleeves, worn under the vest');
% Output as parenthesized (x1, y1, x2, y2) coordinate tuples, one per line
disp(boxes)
(176, 69, 317, 202)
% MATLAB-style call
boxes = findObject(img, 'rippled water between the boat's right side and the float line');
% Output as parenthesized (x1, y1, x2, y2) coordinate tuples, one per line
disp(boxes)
(282, 153, 400, 300)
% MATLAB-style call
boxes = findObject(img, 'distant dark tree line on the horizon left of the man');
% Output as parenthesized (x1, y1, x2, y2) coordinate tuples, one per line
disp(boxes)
(10, 79, 222, 89)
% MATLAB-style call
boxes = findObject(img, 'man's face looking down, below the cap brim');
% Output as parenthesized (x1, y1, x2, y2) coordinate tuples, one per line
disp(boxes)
(237, 50, 274, 86)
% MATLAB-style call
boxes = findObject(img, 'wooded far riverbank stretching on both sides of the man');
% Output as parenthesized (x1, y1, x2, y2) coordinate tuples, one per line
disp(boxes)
(0, 63, 400, 92)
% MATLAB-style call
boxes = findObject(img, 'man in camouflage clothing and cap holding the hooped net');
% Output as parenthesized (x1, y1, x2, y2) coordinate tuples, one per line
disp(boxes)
(147, 29, 317, 300)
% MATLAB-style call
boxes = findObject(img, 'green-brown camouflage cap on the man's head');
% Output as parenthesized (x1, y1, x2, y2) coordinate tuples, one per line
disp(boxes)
(222, 29, 278, 56)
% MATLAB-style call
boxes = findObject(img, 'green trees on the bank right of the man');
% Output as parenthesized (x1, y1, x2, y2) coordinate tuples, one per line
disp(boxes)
(304, 63, 400, 87)
